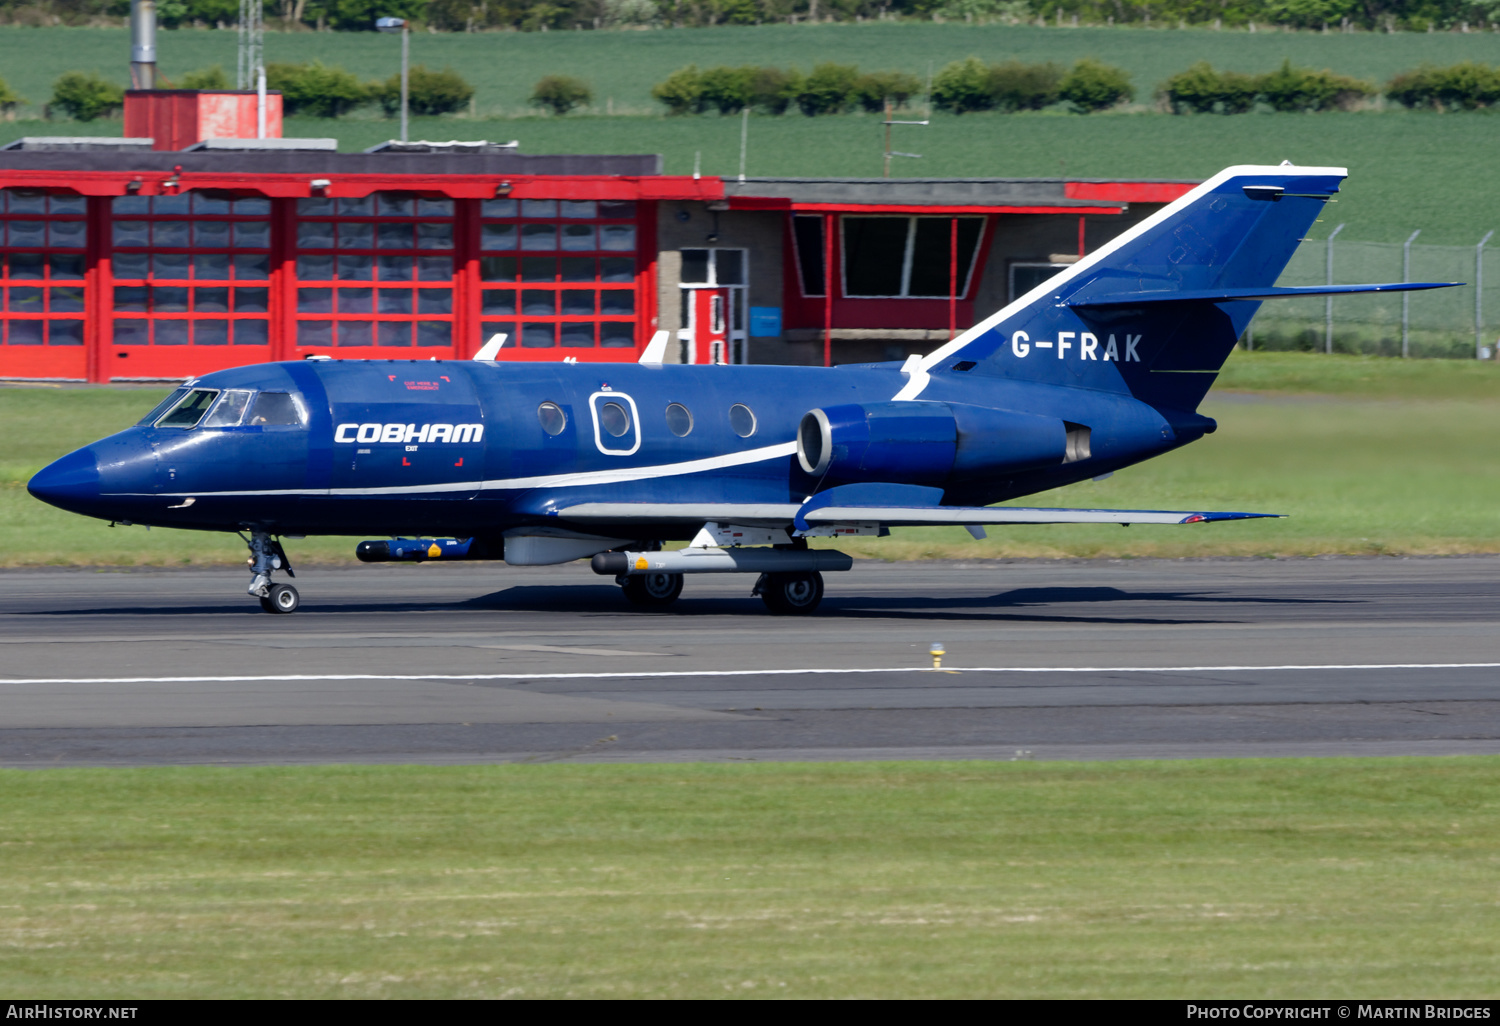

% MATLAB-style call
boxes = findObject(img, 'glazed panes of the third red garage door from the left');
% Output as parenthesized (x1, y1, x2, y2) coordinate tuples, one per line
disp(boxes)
(296, 192, 453, 350)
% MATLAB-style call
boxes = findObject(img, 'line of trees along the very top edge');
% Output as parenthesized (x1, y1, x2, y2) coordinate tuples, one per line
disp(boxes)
(0, 0, 1500, 32)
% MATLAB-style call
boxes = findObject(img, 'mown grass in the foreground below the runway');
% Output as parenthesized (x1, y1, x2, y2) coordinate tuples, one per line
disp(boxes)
(0, 758, 1500, 999)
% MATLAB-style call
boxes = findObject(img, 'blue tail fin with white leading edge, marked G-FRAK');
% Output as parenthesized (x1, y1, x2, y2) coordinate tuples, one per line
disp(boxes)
(899, 167, 1400, 411)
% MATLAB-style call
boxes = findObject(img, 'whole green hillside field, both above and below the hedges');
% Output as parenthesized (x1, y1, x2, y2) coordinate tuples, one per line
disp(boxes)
(0, 24, 1500, 245)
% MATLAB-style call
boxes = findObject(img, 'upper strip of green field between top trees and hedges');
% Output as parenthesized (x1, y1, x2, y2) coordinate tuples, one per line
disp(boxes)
(0, 23, 1500, 114)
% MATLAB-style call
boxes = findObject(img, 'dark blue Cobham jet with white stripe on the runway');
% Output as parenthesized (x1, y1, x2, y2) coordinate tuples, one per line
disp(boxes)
(29, 165, 1452, 615)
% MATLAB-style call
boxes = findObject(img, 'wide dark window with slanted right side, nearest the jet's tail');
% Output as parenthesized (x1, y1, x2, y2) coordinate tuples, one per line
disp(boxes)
(840, 218, 984, 299)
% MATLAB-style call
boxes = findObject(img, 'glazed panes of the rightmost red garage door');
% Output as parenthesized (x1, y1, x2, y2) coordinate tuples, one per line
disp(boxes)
(480, 200, 638, 350)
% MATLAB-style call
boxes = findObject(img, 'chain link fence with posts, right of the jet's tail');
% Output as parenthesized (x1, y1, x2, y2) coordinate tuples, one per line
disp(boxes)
(1241, 233, 1500, 360)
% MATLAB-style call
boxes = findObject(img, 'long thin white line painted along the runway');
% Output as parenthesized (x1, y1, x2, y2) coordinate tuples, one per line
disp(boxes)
(0, 663, 1500, 686)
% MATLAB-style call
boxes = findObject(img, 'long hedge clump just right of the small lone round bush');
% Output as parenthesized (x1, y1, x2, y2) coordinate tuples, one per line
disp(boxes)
(651, 63, 923, 117)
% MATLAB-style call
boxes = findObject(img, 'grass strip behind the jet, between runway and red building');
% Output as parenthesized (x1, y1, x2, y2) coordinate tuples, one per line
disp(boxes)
(0, 353, 1500, 566)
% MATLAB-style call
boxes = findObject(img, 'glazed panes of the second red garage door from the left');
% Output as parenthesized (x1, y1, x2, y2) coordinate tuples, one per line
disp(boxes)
(111, 192, 272, 345)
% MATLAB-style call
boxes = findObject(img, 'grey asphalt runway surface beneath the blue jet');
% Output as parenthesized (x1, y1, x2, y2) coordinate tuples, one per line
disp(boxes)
(0, 558, 1500, 767)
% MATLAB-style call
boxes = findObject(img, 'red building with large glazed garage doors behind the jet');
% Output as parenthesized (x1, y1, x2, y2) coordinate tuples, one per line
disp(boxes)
(0, 140, 1193, 381)
